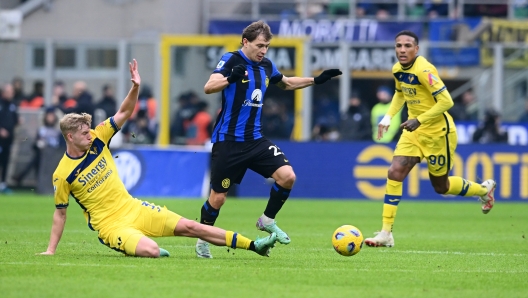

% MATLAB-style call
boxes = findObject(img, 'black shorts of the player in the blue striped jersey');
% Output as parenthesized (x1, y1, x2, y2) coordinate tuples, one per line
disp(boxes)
(211, 138, 290, 193)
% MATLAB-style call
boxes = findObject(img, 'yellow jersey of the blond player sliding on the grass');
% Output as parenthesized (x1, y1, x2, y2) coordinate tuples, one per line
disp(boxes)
(53, 117, 136, 231)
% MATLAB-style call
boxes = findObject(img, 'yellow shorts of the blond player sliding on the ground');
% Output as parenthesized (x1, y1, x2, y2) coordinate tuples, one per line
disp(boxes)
(99, 201, 181, 256)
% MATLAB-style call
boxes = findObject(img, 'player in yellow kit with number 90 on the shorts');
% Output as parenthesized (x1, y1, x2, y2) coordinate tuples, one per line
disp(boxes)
(365, 31, 496, 247)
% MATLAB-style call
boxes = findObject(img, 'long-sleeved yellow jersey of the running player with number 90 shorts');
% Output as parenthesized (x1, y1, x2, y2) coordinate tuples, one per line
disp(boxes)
(387, 56, 456, 136)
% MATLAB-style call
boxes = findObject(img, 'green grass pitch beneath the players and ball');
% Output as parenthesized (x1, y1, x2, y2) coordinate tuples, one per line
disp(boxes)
(0, 194, 528, 298)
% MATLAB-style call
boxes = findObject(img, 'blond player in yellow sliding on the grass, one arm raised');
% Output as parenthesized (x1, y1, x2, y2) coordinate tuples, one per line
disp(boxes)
(37, 60, 277, 258)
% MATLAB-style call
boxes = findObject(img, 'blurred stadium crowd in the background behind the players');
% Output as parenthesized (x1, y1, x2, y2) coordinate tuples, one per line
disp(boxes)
(0, 0, 528, 192)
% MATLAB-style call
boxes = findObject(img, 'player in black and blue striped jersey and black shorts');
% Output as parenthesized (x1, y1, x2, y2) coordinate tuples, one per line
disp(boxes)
(196, 21, 342, 258)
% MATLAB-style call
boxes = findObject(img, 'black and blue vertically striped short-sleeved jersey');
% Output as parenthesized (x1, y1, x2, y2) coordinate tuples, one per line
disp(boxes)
(211, 50, 283, 143)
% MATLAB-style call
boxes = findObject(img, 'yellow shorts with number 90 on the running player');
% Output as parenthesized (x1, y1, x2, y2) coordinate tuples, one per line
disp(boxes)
(394, 130, 457, 176)
